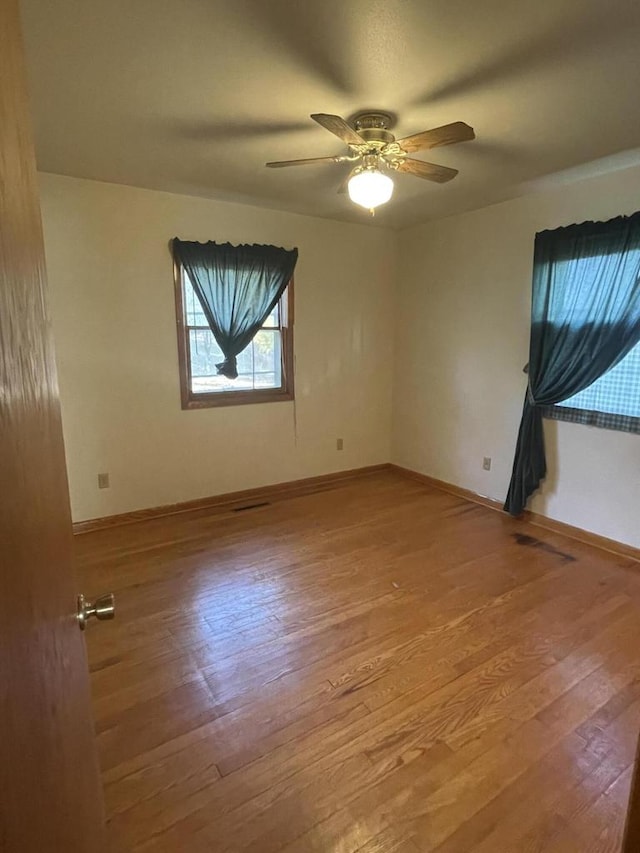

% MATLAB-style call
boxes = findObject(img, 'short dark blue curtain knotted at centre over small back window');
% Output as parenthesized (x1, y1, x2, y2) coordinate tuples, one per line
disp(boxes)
(172, 237, 298, 379)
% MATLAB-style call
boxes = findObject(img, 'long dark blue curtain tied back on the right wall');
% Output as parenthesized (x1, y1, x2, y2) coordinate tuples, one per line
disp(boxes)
(504, 212, 640, 515)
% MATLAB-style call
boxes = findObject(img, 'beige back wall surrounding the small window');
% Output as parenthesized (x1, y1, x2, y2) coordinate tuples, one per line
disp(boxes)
(41, 175, 396, 520)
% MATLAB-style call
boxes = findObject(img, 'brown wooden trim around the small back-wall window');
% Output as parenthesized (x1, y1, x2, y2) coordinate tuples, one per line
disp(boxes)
(173, 261, 295, 409)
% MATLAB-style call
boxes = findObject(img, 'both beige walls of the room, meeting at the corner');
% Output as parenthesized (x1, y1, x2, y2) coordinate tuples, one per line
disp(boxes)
(41, 168, 640, 545)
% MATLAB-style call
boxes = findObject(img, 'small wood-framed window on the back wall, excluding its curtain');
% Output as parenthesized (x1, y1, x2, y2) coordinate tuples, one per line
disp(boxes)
(175, 264, 293, 409)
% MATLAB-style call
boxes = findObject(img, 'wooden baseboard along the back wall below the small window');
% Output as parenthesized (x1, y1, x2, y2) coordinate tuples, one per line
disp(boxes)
(73, 462, 390, 535)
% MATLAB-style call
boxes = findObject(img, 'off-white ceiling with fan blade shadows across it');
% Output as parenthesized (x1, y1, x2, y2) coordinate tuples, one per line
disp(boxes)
(22, 0, 640, 228)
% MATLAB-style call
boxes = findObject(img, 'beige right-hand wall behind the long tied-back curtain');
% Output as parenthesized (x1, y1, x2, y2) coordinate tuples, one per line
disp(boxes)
(392, 162, 640, 546)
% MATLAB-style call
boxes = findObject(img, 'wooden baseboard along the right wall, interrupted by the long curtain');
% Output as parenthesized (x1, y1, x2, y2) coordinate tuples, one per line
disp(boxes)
(389, 464, 640, 561)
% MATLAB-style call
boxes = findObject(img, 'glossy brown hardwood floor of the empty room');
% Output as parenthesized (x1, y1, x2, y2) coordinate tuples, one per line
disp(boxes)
(76, 473, 640, 853)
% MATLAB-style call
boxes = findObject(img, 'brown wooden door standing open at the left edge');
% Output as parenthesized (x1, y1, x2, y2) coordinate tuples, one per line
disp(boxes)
(0, 0, 103, 853)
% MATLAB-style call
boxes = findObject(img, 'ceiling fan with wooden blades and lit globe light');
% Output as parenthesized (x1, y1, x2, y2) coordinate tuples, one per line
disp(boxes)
(266, 112, 475, 213)
